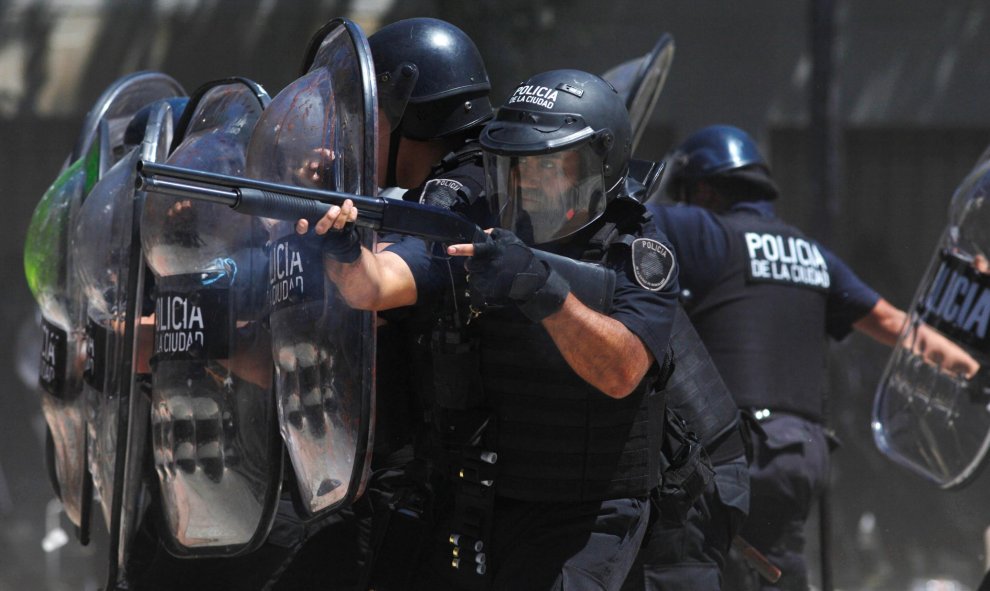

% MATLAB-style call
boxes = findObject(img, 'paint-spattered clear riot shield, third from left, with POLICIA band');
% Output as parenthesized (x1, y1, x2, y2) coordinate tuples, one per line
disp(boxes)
(141, 79, 282, 556)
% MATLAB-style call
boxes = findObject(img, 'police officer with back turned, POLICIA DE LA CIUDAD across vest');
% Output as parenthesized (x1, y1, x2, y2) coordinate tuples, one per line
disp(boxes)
(649, 125, 976, 589)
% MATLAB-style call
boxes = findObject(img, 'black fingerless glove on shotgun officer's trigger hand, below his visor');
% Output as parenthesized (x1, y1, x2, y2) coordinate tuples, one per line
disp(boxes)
(465, 228, 571, 322)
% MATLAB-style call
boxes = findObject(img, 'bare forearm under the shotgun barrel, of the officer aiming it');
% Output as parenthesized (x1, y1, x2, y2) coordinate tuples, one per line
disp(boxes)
(324, 247, 417, 311)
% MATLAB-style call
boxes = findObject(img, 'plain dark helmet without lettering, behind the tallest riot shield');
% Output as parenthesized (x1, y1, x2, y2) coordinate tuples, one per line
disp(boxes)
(368, 18, 492, 140)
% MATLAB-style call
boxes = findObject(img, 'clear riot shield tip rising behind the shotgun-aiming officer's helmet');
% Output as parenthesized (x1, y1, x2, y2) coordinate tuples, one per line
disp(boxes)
(602, 33, 674, 154)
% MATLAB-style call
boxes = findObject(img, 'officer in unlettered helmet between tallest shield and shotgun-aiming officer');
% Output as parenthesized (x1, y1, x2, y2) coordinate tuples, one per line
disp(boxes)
(288, 18, 492, 589)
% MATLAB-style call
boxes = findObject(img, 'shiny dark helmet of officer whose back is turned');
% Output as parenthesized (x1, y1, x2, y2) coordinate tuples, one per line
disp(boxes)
(667, 125, 779, 201)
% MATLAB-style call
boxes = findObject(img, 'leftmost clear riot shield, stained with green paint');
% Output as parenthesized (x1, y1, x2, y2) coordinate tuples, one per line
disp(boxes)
(24, 72, 182, 544)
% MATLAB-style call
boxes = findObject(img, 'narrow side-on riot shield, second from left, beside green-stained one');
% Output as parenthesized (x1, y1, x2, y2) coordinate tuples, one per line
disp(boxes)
(71, 101, 182, 584)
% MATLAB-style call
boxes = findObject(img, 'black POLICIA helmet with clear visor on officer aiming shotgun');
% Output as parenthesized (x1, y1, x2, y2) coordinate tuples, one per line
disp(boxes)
(481, 70, 632, 245)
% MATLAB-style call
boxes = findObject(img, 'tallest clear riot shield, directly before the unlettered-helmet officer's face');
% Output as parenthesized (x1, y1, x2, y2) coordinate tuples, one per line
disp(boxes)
(247, 20, 377, 514)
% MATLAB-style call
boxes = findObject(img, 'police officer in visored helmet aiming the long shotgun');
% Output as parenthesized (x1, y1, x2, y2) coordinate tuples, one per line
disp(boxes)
(316, 70, 677, 589)
